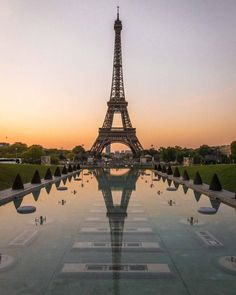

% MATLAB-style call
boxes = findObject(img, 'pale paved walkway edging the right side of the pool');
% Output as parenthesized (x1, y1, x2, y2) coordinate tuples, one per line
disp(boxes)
(155, 170, 236, 208)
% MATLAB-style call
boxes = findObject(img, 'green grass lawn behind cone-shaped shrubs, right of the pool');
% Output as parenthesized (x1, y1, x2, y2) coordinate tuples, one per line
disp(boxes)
(179, 164, 236, 192)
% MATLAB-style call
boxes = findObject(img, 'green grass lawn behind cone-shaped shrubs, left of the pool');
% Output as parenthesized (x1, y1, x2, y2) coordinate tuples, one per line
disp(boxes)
(0, 164, 57, 190)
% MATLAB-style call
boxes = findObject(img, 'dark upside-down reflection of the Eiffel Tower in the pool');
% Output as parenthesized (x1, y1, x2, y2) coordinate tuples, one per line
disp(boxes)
(94, 169, 139, 294)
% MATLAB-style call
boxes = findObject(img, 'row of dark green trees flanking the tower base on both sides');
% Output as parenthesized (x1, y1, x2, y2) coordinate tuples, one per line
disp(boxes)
(0, 141, 236, 164)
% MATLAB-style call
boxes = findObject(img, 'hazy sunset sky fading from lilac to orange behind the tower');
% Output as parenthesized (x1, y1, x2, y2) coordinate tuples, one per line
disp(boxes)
(0, 0, 236, 149)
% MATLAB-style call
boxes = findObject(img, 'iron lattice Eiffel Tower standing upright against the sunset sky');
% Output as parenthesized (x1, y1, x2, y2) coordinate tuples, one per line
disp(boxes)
(90, 7, 143, 155)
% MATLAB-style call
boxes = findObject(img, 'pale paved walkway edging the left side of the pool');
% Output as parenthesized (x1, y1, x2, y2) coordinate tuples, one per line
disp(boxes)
(0, 170, 80, 205)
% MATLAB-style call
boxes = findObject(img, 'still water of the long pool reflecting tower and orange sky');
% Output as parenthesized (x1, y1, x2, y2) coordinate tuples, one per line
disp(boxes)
(0, 169, 236, 295)
